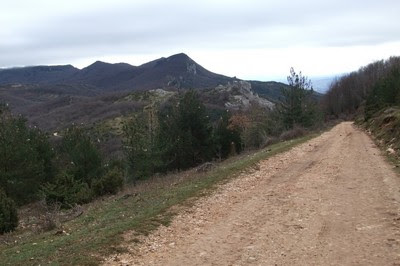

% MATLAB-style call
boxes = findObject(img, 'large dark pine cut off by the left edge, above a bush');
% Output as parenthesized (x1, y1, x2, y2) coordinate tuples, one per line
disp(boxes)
(0, 106, 53, 204)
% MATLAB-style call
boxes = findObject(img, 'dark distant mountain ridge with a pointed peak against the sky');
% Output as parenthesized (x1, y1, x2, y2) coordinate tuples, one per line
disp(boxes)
(0, 54, 233, 91)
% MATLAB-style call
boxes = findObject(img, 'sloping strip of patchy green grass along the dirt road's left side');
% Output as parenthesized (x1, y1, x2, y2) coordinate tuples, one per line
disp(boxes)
(0, 134, 317, 265)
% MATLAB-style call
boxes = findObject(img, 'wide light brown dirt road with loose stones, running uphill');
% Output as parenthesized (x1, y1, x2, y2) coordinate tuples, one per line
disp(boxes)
(105, 122, 400, 265)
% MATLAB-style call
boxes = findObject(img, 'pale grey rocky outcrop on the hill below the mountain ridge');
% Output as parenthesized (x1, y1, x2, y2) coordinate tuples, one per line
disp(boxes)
(215, 80, 275, 110)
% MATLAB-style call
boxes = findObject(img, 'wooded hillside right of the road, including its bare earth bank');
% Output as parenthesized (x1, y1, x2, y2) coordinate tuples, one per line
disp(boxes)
(322, 57, 400, 159)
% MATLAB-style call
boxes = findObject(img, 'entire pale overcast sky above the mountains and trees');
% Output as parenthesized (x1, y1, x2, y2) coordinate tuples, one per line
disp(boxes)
(0, 0, 400, 80)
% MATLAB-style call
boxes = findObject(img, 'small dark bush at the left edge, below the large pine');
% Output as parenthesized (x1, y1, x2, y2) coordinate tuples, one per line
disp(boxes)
(0, 190, 18, 234)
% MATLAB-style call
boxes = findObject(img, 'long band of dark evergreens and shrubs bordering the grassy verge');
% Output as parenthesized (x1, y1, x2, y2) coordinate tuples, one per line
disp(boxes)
(0, 69, 322, 233)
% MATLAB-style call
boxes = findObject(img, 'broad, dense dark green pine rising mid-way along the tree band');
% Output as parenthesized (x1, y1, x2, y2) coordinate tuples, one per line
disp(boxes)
(157, 91, 213, 169)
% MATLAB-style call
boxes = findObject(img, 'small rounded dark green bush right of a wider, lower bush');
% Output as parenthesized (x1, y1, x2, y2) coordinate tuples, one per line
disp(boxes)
(92, 168, 124, 196)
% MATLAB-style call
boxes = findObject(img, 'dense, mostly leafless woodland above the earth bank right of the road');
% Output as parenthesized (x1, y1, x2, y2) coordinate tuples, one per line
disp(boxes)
(322, 57, 400, 119)
